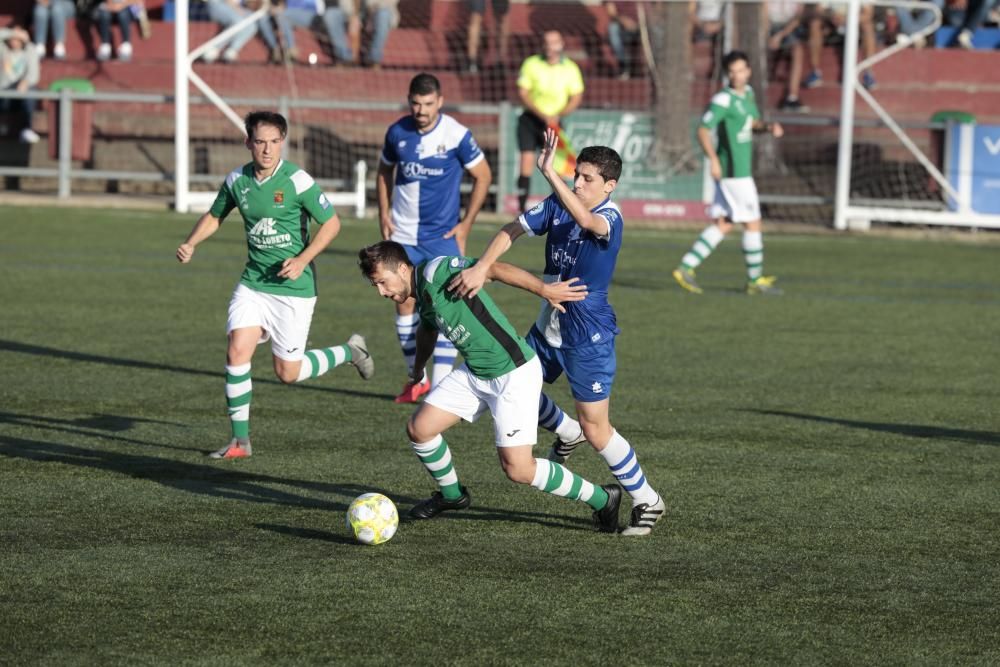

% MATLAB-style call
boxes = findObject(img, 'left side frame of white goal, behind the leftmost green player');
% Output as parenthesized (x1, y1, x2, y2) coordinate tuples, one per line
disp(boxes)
(174, 0, 367, 218)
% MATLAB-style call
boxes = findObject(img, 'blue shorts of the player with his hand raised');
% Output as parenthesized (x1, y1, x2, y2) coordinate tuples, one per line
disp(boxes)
(525, 326, 618, 403)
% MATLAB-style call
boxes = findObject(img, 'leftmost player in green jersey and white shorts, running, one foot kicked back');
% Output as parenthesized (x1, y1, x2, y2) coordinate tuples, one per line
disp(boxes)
(177, 111, 375, 459)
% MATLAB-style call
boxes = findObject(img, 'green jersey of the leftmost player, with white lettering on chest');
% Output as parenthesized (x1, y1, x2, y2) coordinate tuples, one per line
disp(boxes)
(209, 160, 335, 297)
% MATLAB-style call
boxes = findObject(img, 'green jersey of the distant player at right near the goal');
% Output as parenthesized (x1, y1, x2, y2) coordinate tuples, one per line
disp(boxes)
(701, 86, 760, 178)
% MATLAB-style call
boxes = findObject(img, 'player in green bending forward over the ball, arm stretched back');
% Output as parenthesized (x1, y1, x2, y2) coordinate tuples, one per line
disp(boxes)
(358, 241, 622, 533)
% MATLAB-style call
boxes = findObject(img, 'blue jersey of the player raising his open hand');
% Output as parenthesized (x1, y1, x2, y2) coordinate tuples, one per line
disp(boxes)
(518, 195, 625, 348)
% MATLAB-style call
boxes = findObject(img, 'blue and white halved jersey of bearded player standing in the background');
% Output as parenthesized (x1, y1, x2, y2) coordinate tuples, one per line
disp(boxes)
(382, 114, 485, 245)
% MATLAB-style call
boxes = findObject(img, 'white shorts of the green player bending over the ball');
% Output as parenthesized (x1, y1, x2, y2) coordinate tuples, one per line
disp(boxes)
(424, 357, 542, 447)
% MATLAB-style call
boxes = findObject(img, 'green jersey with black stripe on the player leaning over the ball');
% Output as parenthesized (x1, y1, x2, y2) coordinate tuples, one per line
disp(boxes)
(414, 257, 535, 380)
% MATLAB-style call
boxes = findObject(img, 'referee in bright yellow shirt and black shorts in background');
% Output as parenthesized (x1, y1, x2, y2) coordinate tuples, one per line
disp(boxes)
(517, 30, 583, 211)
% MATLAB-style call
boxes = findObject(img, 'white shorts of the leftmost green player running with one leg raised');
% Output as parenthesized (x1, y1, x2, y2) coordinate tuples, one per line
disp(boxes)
(226, 283, 316, 361)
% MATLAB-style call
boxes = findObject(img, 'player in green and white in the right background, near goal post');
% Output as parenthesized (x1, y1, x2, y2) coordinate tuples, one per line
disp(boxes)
(673, 51, 784, 295)
